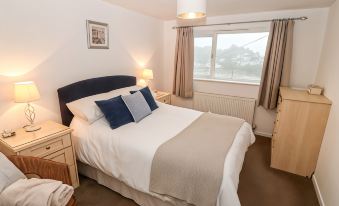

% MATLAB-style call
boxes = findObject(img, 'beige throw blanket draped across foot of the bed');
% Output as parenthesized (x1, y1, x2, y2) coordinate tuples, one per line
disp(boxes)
(150, 113, 244, 206)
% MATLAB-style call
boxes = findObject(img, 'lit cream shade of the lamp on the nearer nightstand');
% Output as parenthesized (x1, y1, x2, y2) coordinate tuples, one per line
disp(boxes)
(14, 81, 40, 103)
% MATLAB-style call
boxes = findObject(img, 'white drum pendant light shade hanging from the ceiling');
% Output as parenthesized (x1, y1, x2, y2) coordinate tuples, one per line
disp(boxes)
(177, 0, 206, 19)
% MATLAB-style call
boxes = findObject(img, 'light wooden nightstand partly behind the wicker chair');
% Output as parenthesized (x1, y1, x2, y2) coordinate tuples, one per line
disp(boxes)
(0, 121, 79, 188)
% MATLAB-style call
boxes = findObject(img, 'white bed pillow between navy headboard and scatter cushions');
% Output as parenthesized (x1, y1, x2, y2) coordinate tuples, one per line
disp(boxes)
(66, 86, 141, 124)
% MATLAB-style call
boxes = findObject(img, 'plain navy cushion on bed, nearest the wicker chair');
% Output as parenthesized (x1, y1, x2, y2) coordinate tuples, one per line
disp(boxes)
(95, 96, 134, 129)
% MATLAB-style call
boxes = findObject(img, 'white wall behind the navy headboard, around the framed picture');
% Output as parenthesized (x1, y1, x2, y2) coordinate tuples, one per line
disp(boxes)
(0, 0, 163, 130)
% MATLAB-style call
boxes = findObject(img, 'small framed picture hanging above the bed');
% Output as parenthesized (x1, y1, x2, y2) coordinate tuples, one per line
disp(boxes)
(87, 20, 109, 49)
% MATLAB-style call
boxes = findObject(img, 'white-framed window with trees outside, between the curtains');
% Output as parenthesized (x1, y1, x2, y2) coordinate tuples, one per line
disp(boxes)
(194, 32, 269, 84)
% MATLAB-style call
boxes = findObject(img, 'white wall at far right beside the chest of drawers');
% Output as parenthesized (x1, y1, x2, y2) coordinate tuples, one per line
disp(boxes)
(315, 1, 339, 206)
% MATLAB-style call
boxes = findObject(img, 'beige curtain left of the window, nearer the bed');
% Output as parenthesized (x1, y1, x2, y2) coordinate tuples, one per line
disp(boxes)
(173, 27, 194, 98)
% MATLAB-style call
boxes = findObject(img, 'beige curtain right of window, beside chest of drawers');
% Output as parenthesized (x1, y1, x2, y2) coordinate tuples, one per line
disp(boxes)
(259, 20, 294, 109)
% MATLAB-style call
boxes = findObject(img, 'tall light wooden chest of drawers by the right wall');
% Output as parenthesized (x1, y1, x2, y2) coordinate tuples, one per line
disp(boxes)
(271, 87, 331, 177)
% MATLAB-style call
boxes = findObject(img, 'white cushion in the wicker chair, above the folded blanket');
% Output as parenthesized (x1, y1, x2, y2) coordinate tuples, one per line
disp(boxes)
(0, 152, 26, 193)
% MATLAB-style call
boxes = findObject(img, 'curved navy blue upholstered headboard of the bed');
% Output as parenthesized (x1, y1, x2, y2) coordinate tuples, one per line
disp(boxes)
(58, 75, 136, 126)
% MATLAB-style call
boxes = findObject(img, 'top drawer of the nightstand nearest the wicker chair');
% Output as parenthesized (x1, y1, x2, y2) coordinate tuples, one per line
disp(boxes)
(19, 135, 71, 157)
